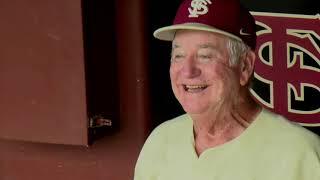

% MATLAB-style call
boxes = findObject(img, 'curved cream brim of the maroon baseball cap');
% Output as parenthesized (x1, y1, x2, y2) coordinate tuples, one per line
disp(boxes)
(153, 23, 242, 41)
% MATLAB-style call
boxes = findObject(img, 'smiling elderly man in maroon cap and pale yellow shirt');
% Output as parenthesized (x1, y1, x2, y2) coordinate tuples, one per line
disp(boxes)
(135, 0, 320, 180)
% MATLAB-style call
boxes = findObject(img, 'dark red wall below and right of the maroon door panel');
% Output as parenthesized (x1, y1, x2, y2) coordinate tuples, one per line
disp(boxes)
(0, 0, 150, 180)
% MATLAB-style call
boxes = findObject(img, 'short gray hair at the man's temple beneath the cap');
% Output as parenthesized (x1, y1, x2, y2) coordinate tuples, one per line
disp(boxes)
(227, 38, 250, 66)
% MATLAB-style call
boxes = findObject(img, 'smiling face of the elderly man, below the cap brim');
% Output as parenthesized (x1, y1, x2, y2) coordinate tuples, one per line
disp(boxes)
(170, 30, 240, 114)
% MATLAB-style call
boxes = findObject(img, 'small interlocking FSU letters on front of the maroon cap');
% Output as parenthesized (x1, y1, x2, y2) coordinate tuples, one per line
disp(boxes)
(188, 0, 211, 17)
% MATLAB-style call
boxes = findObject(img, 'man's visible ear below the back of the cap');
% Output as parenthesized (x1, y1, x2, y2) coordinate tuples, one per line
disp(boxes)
(240, 50, 256, 86)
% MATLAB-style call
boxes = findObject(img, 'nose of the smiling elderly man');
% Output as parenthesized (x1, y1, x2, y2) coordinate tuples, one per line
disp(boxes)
(181, 57, 201, 78)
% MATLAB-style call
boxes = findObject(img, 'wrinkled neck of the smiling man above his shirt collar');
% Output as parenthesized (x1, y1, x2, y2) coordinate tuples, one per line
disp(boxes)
(191, 91, 261, 155)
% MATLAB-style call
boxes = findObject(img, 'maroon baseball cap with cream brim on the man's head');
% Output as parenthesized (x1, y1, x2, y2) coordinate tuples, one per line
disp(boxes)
(153, 0, 257, 49)
